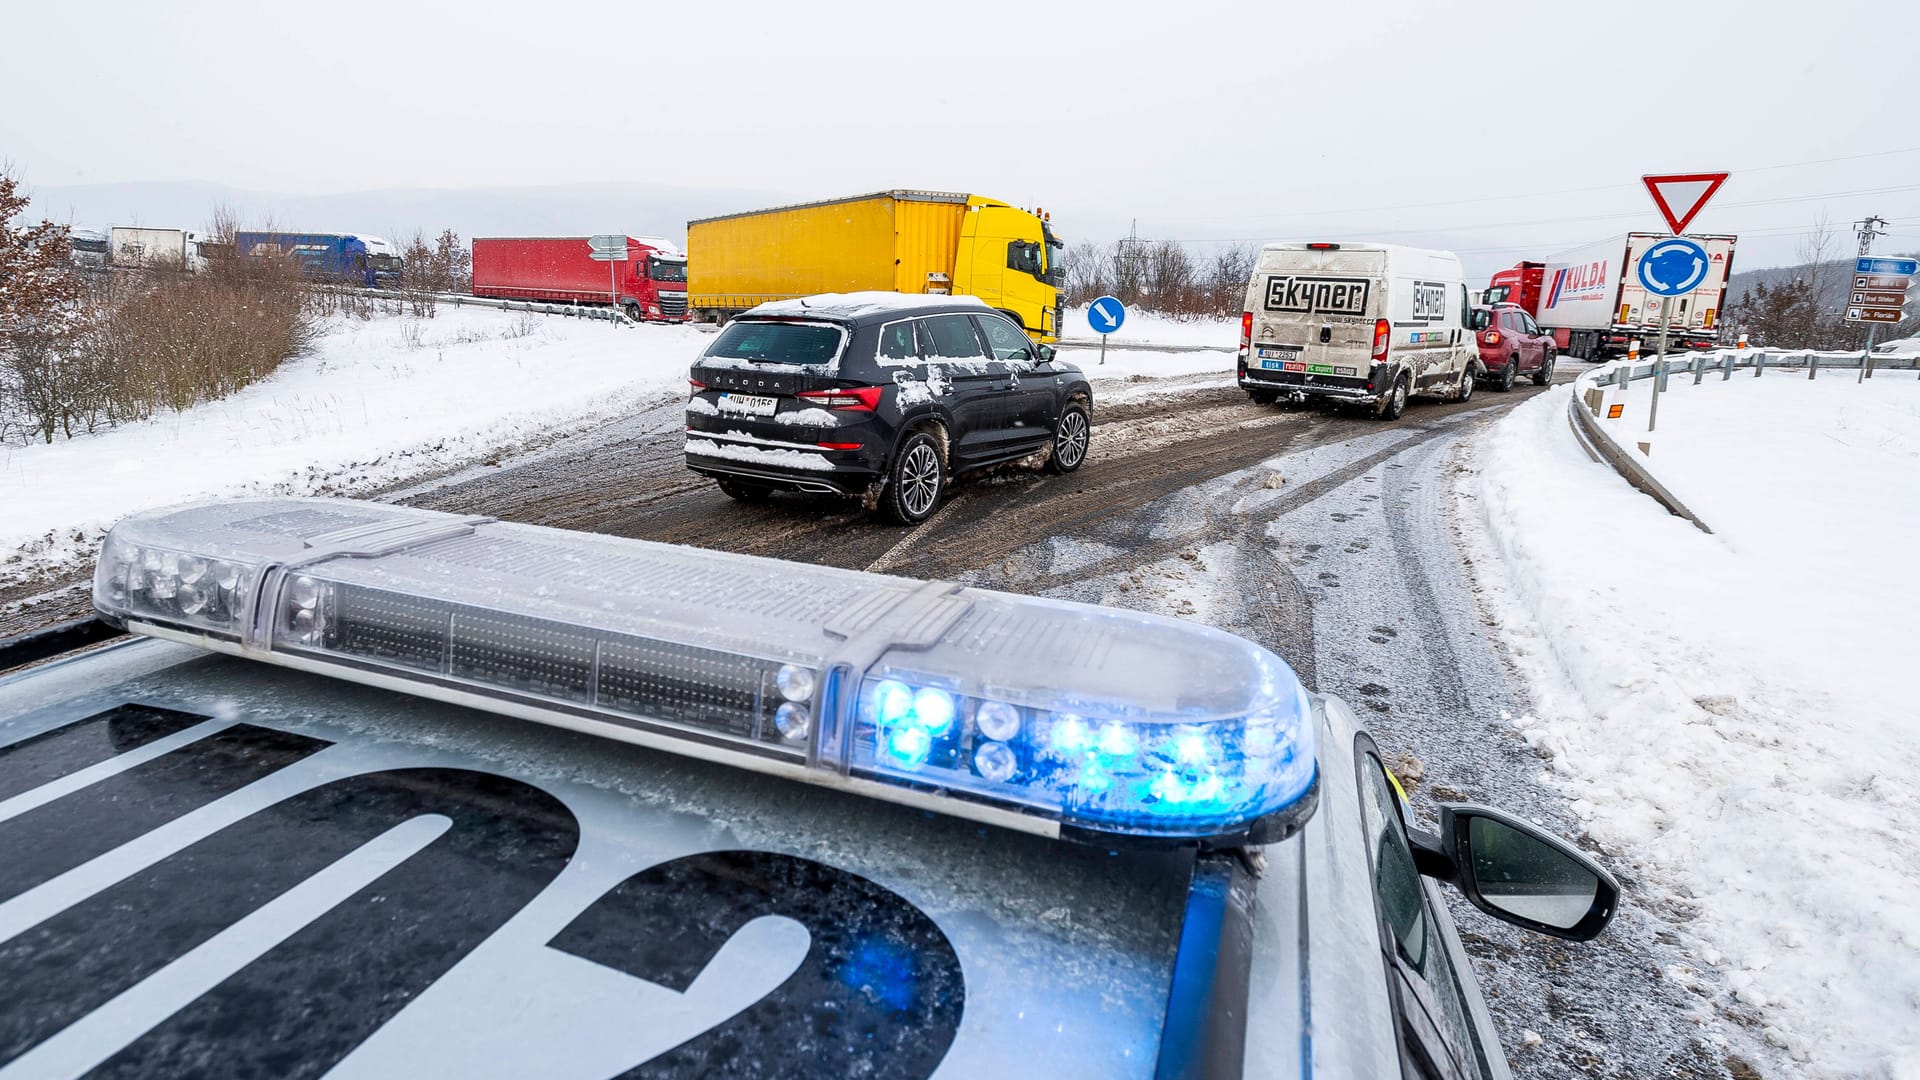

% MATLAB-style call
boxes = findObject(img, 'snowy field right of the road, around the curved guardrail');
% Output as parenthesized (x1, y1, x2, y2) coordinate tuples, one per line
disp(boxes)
(1459, 373, 1920, 1078)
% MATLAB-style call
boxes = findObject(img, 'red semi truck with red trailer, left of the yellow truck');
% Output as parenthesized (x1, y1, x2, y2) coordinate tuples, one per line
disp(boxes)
(474, 236, 687, 323)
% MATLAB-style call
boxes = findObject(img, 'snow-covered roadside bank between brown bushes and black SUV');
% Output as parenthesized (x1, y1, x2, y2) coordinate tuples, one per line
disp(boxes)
(0, 307, 710, 578)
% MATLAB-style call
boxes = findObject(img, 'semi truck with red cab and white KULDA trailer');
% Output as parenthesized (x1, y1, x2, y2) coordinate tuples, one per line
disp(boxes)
(1482, 233, 1736, 359)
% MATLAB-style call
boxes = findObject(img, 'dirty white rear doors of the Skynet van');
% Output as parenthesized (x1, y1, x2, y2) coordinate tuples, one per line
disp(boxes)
(1246, 248, 1386, 384)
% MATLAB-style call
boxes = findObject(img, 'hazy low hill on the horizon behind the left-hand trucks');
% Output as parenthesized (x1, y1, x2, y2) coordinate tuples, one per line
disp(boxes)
(31, 183, 803, 240)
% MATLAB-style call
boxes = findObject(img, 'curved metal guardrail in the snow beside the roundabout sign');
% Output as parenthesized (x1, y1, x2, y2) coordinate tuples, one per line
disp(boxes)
(1567, 348, 1920, 532)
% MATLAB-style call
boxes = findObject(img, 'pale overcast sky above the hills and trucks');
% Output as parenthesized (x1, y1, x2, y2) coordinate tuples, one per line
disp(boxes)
(0, 0, 1920, 267)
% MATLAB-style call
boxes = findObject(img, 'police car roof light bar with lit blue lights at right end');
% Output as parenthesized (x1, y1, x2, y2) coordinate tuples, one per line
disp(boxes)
(94, 500, 1317, 844)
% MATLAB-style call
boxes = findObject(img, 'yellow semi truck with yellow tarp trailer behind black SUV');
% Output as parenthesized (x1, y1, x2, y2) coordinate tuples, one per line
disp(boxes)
(687, 190, 1062, 342)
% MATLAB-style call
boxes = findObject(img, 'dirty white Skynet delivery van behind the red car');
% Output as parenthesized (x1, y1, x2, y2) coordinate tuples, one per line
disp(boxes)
(1238, 244, 1482, 421)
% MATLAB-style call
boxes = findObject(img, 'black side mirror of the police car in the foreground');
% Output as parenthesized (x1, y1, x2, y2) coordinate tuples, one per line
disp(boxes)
(1413, 803, 1620, 942)
